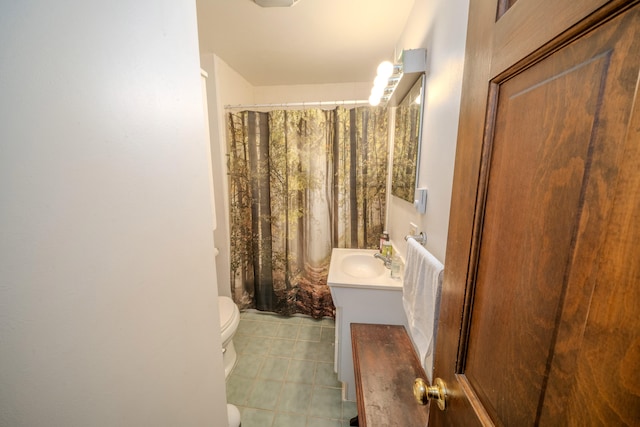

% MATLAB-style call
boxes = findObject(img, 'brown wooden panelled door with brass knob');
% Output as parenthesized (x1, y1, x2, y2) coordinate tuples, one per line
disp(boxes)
(430, 0, 640, 426)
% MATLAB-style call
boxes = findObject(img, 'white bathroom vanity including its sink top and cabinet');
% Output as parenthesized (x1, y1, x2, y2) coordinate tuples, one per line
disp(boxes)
(327, 248, 407, 401)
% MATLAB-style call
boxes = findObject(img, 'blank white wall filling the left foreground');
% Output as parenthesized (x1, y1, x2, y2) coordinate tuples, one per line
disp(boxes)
(0, 0, 227, 427)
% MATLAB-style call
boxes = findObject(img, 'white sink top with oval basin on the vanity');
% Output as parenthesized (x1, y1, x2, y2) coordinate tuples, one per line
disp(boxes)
(327, 248, 402, 289)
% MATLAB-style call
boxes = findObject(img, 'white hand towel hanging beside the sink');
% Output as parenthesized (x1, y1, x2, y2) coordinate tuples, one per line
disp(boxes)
(402, 239, 444, 383)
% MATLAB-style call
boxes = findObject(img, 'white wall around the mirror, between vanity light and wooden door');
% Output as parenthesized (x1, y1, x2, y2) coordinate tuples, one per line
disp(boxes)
(387, 0, 469, 261)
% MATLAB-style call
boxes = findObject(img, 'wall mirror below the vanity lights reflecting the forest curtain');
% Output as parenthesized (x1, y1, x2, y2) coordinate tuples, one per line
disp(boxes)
(391, 74, 425, 203)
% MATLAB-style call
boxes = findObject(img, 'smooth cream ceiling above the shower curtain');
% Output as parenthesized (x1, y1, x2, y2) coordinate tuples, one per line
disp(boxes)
(196, 0, 415, 86)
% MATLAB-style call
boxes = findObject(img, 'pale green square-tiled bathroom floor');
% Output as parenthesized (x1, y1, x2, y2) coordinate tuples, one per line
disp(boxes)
(227, 311, 357, 427)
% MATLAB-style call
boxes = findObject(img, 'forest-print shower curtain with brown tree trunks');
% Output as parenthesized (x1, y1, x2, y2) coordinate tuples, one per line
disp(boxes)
(227, 107, 388, 318)
